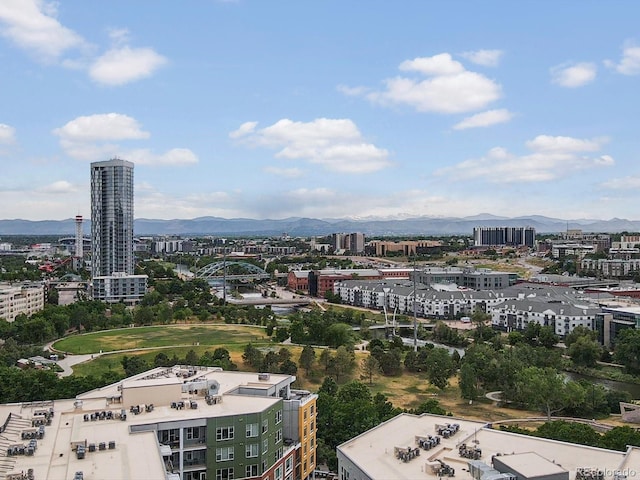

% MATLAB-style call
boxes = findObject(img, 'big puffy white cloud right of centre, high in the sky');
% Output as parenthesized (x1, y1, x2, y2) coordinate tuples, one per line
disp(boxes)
(366, 53, 502, 113)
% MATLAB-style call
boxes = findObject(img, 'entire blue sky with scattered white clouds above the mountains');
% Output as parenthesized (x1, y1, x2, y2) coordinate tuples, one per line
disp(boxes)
(0, 0, 640, 220)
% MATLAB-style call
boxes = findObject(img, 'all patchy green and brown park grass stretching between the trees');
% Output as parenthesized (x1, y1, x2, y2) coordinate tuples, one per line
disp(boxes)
(54, 324, 536, 420)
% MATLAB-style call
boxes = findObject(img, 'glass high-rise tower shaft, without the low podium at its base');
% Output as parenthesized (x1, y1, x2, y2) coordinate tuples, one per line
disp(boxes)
(91, 158, 134, 277)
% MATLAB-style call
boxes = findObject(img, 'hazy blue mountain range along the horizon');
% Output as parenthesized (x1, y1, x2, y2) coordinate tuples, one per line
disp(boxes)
(0, 214, 640, 237)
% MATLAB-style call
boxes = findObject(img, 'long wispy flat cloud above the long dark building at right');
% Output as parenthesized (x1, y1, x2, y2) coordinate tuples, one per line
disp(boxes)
(436, 135, 615, 183)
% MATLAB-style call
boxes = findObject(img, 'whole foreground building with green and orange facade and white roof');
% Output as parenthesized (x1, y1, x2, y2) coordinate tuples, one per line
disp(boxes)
(0, 366, 317, 480)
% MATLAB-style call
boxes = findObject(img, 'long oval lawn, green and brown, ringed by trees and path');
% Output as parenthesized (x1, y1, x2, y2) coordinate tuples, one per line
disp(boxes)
(53, 324, 268, 354)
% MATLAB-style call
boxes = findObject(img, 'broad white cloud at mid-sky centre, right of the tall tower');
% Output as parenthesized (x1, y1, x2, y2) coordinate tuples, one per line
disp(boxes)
(231, 118, 390, 173)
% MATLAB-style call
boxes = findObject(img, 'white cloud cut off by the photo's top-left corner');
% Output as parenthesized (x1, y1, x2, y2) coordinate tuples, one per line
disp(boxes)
(0, 0, 85, 61)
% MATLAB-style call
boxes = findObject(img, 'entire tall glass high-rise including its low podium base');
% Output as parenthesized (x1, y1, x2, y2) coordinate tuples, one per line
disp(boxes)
(91, 158, 147, 304)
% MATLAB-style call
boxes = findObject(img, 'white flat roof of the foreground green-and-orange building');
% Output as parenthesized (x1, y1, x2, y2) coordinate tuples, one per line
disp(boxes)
(0, 366, 304, 480)
